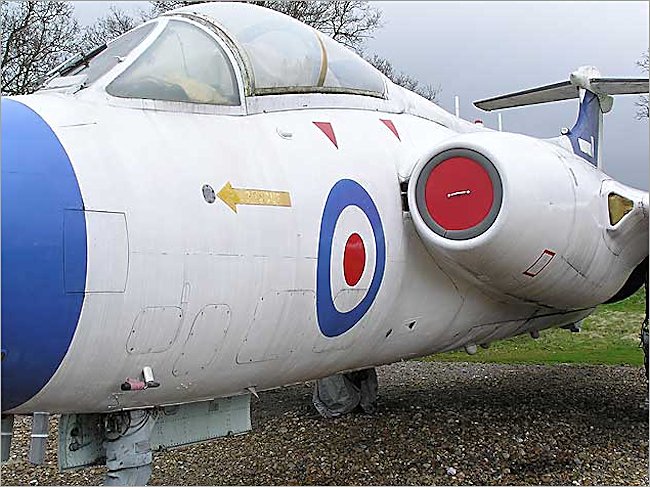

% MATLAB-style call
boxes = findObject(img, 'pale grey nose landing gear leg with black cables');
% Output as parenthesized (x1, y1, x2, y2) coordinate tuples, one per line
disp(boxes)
(104, 409, 157, 485)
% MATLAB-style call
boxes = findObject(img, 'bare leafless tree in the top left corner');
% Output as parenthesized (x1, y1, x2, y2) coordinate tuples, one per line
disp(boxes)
(0, 1, 79, 95)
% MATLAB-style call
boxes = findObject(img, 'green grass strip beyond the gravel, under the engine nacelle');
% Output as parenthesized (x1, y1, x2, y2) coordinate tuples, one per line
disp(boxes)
(425, 288, 645, 366)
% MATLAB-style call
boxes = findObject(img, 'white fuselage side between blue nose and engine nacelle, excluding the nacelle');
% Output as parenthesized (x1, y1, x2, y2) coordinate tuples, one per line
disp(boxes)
(8, 80, 625, 413)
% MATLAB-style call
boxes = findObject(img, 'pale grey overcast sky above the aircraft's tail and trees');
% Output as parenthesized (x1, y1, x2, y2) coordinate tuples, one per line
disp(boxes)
(73, 1, 650, 190)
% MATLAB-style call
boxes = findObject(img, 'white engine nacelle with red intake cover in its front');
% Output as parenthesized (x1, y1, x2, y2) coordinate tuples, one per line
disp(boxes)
(408, 132, 648, 309)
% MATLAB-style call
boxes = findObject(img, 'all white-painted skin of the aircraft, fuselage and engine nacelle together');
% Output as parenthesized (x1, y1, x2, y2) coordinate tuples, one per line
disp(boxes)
(6, 6, 647, 413)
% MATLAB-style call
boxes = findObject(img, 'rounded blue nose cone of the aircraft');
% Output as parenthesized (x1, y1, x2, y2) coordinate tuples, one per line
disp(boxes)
(1, 98, 86, 411)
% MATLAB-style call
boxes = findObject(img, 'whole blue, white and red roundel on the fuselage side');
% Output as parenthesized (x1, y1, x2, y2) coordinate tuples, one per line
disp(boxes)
(316, 179, 386, 337)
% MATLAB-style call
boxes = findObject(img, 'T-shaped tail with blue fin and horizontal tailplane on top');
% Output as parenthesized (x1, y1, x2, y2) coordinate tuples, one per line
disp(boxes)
(474, 66, 649, 168)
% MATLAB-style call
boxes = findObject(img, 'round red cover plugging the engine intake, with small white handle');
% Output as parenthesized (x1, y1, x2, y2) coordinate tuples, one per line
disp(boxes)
(424, 157, 494, 230)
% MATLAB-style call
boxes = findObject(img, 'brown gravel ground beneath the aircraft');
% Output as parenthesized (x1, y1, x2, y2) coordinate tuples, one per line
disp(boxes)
(1, 361, 648, 485)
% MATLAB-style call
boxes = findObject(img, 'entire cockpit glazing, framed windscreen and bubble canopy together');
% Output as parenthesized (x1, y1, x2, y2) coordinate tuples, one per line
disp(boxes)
(61, 2, 385, 106)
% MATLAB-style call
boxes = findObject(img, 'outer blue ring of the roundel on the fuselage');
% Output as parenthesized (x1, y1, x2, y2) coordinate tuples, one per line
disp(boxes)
(316, 179, 386, 337)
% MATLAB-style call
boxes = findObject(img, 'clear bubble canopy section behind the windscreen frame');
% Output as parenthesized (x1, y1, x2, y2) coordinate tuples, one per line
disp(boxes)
(172, 2, 384, 96)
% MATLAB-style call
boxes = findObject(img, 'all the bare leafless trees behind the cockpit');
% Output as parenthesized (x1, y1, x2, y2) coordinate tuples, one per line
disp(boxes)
(1, 0, 440, 101)
